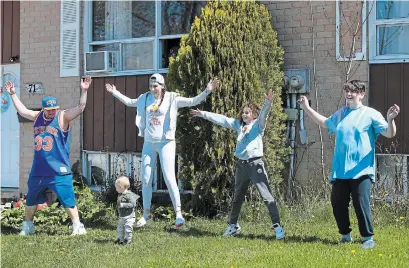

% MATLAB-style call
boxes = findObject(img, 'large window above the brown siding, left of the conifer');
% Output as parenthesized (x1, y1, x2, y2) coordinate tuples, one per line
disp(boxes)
(84, 1, 206, 76)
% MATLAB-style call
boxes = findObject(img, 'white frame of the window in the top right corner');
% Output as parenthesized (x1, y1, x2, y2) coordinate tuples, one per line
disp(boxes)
(369, 0, 409, 63)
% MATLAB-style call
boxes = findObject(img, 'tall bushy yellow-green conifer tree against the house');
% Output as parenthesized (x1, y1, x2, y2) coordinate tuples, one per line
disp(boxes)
(167, 1, 287, 216)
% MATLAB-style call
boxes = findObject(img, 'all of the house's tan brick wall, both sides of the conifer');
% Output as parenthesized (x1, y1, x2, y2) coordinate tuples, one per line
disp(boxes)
(13, 1, 368, 193)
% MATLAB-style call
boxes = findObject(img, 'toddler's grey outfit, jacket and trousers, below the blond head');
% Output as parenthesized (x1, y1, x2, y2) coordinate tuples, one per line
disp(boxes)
(117, 191, 139, 243)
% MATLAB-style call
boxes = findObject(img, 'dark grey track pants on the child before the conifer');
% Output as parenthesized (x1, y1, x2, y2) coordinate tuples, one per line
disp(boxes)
(229, 158, 280, 224)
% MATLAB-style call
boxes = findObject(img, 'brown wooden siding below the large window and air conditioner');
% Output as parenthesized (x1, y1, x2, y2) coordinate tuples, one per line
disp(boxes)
(84, 75, 149, 152)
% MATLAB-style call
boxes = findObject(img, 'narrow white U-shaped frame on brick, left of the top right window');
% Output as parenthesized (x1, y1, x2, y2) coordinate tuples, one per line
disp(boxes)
(335, 0, 367, 61)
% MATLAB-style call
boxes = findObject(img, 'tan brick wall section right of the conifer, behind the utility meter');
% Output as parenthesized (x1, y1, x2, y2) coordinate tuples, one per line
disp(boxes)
(266, 1, 368, 182)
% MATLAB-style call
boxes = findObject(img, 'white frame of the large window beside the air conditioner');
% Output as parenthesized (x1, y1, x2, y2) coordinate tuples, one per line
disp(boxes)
(84, 1, 192, 77)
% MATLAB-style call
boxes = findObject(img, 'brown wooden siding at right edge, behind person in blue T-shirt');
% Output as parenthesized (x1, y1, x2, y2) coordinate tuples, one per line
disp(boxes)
(369, 63, 409, 154)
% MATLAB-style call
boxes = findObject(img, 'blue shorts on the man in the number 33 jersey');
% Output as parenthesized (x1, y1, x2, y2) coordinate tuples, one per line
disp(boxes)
(26, 174, 76, 208)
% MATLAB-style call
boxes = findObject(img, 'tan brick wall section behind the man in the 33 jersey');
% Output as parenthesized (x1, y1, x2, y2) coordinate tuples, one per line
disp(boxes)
(20, 1, 81, 193)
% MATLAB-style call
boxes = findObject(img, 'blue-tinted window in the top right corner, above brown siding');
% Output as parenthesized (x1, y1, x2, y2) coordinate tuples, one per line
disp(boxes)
(369, 1, 409, 63)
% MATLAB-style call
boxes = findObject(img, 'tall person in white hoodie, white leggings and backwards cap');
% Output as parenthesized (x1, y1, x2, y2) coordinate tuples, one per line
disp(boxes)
(105, 73, 218, 228)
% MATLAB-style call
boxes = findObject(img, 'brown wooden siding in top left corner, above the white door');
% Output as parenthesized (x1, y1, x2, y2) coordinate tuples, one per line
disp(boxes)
(0, 1, 20, 64)
